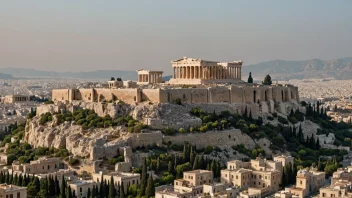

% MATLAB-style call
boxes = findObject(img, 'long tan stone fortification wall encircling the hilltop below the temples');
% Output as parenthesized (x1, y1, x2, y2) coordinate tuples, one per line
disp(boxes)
(52, 85, 299, 104)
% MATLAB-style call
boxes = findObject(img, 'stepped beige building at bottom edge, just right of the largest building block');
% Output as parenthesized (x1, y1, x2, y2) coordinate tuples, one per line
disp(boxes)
(285, 169, 325, 198)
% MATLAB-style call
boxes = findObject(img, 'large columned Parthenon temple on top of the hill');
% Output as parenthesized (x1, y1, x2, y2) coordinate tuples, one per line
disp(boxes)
(169, 57, 243, 84)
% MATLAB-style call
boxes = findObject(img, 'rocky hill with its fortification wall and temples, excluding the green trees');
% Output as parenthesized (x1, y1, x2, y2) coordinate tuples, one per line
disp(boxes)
(24, 57, 310, 167)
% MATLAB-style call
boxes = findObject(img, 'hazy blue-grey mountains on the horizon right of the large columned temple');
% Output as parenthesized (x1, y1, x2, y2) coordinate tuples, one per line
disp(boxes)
(242, 57, 352, 80)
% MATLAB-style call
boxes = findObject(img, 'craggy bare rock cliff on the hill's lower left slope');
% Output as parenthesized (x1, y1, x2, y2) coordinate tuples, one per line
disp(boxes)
(23, 117, 129, 159)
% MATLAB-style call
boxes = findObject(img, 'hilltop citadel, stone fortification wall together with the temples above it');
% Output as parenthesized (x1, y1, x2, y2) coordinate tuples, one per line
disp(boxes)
(52, 57, 299, 104)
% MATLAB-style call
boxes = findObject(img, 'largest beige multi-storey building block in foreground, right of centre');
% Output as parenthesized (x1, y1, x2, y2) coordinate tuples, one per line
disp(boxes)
(221, 158, 282, 196)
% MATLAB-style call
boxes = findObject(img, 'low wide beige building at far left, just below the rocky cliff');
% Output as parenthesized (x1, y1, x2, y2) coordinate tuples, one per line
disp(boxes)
(12, 157, 66, 174)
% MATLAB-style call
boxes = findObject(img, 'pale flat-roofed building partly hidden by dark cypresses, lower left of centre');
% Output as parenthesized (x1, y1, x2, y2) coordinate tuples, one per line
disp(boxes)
(93, 172, 141, 192)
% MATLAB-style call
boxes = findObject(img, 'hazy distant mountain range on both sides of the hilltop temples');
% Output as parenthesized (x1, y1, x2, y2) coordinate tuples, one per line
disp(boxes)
(0, 57, 352, 81)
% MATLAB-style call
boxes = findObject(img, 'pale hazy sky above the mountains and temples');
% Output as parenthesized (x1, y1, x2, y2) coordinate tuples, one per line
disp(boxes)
(0, 0, 352, 73)
